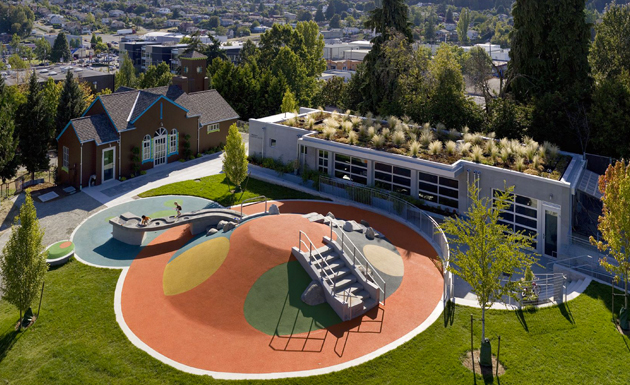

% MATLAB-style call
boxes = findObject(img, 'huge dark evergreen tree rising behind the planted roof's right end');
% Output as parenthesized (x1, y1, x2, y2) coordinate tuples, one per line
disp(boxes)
(508, 0, 591, 151)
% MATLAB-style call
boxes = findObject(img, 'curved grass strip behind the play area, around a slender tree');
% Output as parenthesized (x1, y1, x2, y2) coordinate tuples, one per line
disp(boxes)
(140, 174, 325, 207)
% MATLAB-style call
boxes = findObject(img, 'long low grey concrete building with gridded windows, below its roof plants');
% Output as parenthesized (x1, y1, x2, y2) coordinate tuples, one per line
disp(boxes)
(249, 108, 594, 258)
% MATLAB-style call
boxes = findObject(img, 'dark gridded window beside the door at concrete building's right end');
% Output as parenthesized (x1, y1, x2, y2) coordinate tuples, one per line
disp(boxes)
(493, 190, 538, 248)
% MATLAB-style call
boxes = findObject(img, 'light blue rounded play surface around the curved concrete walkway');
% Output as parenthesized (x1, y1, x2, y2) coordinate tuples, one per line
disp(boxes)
(72, 195, 222, 267)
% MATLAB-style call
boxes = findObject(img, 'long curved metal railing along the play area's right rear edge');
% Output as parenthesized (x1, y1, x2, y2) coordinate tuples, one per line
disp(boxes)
(319, 176, 453, 301)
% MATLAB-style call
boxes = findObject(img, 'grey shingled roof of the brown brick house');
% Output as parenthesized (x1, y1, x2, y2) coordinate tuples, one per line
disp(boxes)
(63, 86, 238, 145)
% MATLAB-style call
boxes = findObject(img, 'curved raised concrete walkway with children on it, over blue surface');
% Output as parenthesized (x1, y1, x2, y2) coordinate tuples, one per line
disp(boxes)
(109, 209, 242, 246)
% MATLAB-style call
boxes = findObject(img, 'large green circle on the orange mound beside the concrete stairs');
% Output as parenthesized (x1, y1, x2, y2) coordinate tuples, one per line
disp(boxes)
(243, 261, 341, 336)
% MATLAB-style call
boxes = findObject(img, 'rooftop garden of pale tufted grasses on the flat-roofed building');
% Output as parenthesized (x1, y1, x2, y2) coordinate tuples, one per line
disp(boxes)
(280, 109, 571, 180)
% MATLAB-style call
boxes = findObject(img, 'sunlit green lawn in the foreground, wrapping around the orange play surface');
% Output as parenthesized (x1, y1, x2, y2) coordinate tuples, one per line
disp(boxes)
(0, 261, 630, 384)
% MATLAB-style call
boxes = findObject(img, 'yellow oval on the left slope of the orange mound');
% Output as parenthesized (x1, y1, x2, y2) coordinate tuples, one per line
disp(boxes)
(162, 237, 230, 295)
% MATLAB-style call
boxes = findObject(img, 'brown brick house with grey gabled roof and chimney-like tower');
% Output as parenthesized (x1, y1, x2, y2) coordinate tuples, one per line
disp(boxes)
(57, 52, 238, 189)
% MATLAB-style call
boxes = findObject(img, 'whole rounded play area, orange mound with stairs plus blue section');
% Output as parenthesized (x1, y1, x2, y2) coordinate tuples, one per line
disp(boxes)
(73, 196, 444, 379)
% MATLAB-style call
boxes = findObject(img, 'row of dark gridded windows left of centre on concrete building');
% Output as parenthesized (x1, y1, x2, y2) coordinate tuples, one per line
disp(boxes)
(324, 150, 459, 209)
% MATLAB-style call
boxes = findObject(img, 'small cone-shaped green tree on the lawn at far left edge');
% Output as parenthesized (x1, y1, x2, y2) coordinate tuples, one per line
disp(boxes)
(0, 190, 48, 326)
